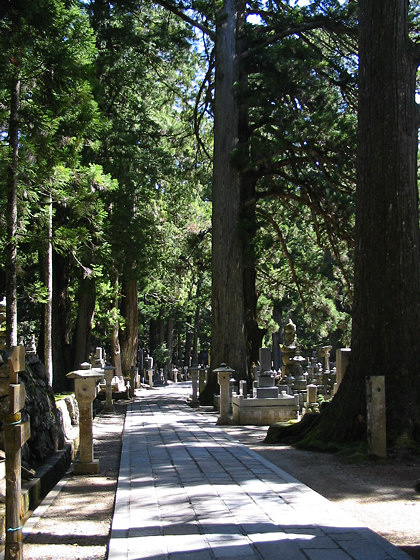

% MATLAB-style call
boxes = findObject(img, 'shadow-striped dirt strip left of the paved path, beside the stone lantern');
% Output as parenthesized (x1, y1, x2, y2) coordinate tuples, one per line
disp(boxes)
(18, 401, 127, 560)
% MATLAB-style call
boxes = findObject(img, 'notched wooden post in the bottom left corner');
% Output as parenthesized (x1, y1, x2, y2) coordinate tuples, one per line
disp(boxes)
(3, 346, 30, 560)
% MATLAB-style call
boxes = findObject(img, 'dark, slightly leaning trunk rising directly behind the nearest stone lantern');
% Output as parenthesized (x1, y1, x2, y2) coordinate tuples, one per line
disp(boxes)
(72, 276, 96, 369)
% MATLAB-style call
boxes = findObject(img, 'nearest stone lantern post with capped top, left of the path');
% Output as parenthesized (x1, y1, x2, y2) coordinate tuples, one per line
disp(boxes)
(67, 363, 104, 474)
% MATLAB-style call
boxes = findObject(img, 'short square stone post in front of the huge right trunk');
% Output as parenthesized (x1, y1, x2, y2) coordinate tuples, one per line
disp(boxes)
(366, 375, 386, 457)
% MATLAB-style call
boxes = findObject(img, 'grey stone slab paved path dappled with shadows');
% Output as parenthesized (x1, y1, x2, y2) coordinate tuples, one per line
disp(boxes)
(108, 383, 409, 560)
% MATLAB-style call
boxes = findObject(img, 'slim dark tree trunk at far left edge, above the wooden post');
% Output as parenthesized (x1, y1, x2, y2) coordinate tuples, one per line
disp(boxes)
(6, 72, 20, 348)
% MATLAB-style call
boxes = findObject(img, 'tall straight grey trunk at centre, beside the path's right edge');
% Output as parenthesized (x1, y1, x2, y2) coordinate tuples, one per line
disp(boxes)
(200, 0, 247, 402)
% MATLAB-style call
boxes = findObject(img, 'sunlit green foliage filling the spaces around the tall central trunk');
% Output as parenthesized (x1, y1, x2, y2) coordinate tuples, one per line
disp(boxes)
(0, 0, 358, 376)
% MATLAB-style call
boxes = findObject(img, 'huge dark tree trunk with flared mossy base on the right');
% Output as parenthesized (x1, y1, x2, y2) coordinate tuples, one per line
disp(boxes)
(270, 0, 420, 449)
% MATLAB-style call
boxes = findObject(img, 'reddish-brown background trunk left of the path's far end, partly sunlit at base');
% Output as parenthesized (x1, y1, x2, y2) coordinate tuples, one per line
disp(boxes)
(120, 278, 139, 375)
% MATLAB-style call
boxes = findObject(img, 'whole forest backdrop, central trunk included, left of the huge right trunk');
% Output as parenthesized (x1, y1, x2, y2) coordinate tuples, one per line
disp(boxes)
(0, 0, 419, 450)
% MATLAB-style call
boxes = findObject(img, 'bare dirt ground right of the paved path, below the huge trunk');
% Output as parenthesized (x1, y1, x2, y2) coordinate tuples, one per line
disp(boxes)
(221, 426, 420, 560)
